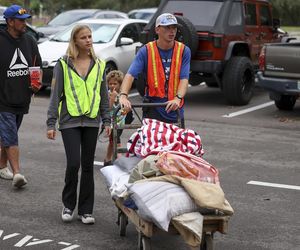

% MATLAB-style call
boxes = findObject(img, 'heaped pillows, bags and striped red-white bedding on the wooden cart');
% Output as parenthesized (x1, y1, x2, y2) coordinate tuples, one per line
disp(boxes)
(100, 119, 233, 246)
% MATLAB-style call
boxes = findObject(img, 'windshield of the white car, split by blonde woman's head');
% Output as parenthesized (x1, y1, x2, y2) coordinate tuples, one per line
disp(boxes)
(51, 23, 119, 43)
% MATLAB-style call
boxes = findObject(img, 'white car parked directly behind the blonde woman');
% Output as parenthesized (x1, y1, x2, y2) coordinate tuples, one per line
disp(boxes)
(38, 19, 147, 87)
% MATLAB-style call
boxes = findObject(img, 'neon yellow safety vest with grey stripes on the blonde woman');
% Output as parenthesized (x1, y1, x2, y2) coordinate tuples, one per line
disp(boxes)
(60, 59, 105, 118)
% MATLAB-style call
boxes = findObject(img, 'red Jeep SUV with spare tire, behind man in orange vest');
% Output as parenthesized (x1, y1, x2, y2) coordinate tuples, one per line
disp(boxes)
(141, 0, 284, 105)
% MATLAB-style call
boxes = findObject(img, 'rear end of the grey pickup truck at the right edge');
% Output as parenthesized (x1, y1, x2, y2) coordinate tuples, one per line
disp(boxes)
(257, 41, 300, 110)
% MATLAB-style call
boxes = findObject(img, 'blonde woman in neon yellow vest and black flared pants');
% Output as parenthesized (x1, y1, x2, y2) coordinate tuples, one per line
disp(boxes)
(47, 25, 111, 224)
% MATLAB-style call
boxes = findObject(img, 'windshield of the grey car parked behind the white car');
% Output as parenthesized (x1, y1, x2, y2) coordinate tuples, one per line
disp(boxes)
(48, 12, 94, 26)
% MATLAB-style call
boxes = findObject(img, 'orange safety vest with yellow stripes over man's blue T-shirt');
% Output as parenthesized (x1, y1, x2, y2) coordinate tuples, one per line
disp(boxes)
(146, 41, 184, 100)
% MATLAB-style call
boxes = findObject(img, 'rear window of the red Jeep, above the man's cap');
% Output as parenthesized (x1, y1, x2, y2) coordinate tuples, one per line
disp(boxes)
(162, 1, 223, 27)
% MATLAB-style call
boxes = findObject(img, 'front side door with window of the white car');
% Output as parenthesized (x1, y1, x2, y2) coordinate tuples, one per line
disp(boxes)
(116, 23, 145, 73)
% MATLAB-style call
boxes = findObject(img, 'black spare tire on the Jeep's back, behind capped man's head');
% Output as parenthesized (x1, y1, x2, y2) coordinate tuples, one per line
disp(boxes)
(148, 16, 199, 56)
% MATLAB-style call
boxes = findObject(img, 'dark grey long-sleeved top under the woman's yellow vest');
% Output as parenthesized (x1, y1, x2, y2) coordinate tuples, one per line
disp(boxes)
(46, 57, 110, 130)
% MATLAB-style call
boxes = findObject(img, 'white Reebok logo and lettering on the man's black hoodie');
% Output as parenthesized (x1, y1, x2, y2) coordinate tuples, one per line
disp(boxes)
(7, 48, 29, 78)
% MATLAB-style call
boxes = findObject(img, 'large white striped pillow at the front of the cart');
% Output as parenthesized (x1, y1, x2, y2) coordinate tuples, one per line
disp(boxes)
(128, 181, 199, 231)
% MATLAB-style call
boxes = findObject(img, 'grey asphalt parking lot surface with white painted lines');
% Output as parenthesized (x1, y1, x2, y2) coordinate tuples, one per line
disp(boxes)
(0, 85, 300, 250)
